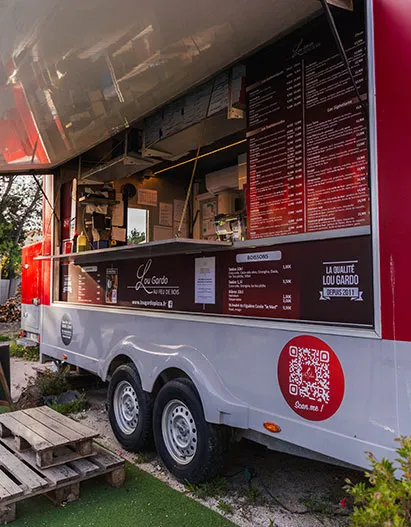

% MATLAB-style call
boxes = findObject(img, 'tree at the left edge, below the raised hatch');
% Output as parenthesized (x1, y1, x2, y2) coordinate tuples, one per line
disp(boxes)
(0, 175, 42, 278)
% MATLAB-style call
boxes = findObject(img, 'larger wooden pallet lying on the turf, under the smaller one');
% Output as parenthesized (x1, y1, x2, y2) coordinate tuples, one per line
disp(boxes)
(0, 437, 125, 525)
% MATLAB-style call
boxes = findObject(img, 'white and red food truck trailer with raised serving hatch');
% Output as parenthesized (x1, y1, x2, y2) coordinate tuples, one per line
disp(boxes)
(4, 0, 411, 483)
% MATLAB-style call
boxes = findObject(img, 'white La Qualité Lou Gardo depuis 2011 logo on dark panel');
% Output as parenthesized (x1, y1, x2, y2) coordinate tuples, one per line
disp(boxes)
(320, 260, 364, 302)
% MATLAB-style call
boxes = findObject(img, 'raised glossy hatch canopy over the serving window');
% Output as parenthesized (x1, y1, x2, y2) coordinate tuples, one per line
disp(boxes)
(0, 0, 320, 172)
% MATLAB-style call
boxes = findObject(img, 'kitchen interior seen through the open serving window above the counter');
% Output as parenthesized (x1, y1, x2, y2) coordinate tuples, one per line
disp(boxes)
(56, 66, 247, 254)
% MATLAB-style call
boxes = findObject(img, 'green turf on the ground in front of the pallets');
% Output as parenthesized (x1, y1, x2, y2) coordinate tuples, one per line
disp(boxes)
(11, 464, 233, 527)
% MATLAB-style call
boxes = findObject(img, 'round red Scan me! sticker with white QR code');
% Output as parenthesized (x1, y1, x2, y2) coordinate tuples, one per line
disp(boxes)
(278, 335, 345, 421)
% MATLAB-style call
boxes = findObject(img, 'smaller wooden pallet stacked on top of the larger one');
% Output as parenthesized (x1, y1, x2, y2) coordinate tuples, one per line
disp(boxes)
(0, 406, 99, 468)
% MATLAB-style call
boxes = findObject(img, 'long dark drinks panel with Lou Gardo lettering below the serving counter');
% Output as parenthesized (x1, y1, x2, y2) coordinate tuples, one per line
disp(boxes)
(60, 236, 373, 326)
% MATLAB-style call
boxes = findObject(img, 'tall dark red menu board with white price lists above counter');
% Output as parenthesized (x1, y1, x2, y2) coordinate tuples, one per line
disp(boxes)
(247, 3, 370, 238)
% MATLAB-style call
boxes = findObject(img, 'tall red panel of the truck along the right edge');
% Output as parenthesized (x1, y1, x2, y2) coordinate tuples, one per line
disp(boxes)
(374, 0, 411, 341)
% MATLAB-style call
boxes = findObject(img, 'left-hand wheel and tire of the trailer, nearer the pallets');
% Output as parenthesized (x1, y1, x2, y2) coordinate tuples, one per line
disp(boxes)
(108, 364, 153, 452)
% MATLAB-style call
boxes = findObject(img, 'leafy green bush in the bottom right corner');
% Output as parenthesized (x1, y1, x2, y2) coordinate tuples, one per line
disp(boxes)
(346, 437, 411, 527)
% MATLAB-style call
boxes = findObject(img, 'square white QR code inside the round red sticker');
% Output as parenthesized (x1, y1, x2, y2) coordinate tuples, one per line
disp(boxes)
(289, 346, 330, 403)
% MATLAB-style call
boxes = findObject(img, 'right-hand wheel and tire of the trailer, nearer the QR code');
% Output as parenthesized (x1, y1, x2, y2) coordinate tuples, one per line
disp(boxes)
(153, 379, 224, 484)
